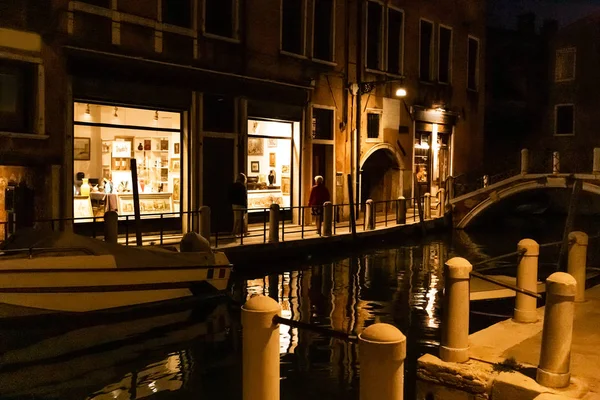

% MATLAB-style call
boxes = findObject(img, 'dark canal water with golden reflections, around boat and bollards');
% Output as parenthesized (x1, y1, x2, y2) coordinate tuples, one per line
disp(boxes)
(0, 218, 599, 400)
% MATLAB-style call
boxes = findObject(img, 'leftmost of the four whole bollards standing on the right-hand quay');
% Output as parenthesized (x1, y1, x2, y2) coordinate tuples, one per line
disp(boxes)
(440, 257, 473, 362)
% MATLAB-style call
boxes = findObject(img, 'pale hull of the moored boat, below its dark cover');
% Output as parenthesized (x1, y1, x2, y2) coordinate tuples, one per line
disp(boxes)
(0, 256, 231, 318)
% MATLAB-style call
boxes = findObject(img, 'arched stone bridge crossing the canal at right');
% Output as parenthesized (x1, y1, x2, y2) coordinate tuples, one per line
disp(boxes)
(450, 173, 600, 229)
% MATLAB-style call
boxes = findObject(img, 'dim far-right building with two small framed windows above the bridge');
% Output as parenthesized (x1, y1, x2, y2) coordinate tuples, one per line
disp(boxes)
(530, 13, 600, 172)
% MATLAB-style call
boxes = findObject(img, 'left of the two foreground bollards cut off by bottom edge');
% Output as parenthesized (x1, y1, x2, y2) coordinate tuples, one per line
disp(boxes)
(242, 296, 281, 400)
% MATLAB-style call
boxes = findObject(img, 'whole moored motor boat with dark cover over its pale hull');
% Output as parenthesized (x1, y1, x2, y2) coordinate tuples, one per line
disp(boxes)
(0, 230, 231, 318)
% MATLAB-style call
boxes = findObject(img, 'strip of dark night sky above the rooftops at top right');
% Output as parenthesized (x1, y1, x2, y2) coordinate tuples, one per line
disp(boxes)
(487, 0, 600, 28)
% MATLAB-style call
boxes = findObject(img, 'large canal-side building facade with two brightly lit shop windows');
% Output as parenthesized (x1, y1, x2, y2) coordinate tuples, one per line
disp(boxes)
(0, 0, 485, 236)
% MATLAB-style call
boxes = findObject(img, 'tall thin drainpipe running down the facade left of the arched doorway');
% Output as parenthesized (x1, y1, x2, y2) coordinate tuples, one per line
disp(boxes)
(354, 1, 363, 216)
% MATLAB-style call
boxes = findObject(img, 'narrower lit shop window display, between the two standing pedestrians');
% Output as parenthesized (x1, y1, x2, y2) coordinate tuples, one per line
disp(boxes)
(247, 120, 292, 211)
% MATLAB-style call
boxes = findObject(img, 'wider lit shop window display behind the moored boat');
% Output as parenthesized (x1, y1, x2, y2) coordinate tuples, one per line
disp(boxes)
(73, 103, 182, 222)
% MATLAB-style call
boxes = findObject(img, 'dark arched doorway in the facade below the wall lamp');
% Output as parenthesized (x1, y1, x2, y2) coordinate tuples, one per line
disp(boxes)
(360, 145, 401, 204)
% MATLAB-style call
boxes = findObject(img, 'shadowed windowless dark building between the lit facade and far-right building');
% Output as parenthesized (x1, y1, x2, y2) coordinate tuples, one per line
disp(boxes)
(480, 13, 558, 176)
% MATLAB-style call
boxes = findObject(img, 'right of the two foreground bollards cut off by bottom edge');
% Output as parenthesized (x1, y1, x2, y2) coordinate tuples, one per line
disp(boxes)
(358, 323, 406, 400)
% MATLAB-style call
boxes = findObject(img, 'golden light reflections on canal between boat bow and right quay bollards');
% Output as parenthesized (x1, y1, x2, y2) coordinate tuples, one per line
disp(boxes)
(234, 241, 448, 399)
